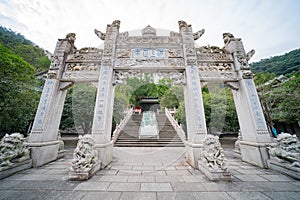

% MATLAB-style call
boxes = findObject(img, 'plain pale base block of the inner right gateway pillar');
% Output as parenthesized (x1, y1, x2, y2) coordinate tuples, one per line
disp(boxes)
(184, 142, 203, 169)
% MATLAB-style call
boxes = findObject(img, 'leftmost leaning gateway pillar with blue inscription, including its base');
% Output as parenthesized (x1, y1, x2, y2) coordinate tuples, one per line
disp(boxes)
(28, 34, 75, 167)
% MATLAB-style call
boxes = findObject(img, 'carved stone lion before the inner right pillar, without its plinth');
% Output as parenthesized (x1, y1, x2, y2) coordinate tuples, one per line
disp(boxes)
(202, 135, 226, 169)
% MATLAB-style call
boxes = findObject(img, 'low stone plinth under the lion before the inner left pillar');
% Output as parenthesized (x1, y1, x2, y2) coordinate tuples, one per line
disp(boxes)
(69, 161, 101, 181)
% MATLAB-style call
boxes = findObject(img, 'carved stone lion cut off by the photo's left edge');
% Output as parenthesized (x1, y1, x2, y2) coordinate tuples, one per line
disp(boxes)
(0, 133, 30, 169)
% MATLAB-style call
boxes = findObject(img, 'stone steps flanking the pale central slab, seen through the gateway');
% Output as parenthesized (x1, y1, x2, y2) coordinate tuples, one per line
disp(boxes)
(114, 114, 184, 147)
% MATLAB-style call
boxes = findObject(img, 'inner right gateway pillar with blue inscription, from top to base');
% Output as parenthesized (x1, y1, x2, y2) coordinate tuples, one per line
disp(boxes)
(179, 22, 207, 168)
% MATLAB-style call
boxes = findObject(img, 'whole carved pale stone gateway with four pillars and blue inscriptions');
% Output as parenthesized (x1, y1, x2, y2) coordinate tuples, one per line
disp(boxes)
(29, 21, 271, 168)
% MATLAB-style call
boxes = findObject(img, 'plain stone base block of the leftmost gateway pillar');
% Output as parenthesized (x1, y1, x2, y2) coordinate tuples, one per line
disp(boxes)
(28, 140, 59, 167)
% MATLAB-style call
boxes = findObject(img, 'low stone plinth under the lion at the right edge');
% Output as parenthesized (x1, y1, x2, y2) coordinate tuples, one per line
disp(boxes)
(268, 160, 300, 180)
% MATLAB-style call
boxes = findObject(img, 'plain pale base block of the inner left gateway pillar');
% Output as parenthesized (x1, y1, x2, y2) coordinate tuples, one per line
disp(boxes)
(95, 141, 113, 169)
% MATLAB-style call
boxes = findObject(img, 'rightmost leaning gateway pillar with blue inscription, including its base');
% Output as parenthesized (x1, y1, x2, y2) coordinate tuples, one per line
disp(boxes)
(225, 35, 271, 168)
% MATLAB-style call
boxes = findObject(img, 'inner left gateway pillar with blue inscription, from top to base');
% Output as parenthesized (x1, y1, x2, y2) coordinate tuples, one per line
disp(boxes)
(92, 21, 120, 168)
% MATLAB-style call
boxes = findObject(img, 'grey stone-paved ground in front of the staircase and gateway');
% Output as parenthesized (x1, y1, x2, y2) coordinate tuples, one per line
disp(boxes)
(0, 144, 300, 200)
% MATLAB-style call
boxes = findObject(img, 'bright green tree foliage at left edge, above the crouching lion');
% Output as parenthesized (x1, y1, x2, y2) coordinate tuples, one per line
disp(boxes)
(0, 43, 40, 133)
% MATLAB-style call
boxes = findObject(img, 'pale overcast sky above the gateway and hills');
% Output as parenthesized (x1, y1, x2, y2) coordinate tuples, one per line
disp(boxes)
(0, 0, 300, 61)
